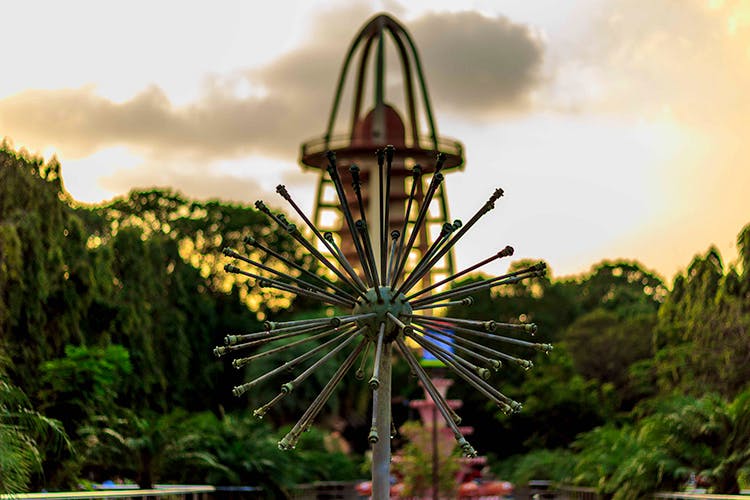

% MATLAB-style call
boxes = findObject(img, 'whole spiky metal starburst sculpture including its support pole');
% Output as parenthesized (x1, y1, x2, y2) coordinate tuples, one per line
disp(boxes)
(214, 146, 552, 498)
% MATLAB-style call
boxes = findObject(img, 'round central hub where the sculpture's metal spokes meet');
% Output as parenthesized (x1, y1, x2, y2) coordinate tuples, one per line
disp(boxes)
(352, 286, 412, 342)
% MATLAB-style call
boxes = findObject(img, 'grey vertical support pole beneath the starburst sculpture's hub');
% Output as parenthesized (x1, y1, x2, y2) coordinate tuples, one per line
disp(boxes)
(372, 342, 393, 500)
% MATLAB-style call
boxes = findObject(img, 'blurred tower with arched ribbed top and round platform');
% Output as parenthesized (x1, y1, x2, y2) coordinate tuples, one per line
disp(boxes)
(300, 14, 464, 287)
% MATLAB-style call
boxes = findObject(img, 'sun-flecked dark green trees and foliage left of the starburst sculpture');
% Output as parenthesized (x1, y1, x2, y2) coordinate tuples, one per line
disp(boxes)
(0, 144, 362, 494)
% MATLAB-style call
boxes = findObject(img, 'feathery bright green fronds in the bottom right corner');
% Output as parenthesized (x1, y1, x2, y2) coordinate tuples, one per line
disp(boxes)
(571, 390, 750, 499)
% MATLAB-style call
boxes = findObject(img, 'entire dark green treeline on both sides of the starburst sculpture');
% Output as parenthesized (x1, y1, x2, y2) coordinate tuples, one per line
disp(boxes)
(0, 145, 750, 498)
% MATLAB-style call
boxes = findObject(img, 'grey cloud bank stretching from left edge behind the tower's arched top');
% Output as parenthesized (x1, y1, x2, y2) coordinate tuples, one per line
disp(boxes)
(0, 4, 543, 161)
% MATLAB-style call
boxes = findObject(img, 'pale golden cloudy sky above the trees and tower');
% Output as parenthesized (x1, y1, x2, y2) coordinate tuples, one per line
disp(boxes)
(0, 0, 750, 280)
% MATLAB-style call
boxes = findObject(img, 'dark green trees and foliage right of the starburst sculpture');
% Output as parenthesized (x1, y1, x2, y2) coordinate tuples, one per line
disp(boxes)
(453, 230, 750, 492)
